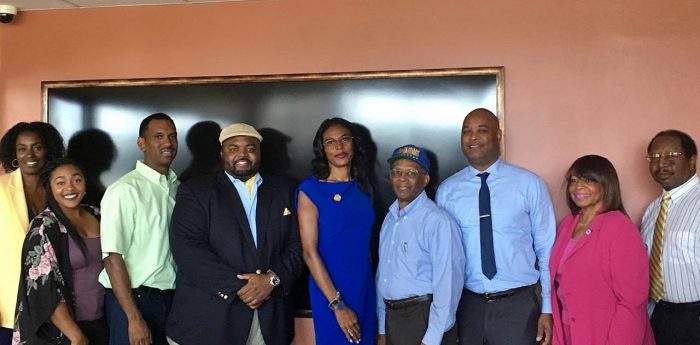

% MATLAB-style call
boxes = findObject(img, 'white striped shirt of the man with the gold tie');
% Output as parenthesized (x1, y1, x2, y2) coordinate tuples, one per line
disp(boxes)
(642, 175, 700, 303)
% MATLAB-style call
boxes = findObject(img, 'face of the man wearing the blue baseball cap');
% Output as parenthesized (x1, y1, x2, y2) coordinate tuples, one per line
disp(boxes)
(389, 159, 430, 208)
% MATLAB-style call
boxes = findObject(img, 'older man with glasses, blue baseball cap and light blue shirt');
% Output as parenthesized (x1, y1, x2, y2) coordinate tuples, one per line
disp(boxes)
(376, 145, 464, 345)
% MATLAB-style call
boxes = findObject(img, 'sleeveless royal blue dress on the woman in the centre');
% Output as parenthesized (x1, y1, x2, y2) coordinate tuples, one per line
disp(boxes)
(299, 176, 377, 345)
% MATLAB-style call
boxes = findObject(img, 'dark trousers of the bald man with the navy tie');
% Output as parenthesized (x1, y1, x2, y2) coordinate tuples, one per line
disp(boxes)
(457, 285, 541, 345)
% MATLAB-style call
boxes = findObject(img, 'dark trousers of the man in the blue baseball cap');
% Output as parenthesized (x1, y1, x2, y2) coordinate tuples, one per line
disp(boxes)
(385, 295, 457, 345)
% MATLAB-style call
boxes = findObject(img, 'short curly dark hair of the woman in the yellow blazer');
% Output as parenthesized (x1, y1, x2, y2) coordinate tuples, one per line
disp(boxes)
(0, 121, 66, 172)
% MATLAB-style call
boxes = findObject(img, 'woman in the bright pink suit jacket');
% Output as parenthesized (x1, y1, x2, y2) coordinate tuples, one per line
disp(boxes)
(549, 155, 655, 345)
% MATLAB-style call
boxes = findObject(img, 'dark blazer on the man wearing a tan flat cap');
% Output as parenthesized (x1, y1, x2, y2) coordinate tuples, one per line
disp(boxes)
(166, 171, 303, 345)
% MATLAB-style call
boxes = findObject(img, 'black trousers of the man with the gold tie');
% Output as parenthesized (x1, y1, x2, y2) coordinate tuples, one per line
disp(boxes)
(651, 301, 700, 345)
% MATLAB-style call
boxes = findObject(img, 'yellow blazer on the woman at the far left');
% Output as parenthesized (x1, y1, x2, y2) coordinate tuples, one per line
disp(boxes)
(0, 169, 29, 328)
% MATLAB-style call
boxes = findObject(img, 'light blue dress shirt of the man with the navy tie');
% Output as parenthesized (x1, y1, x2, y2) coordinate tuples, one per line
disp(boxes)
(436, 159, 556, 313)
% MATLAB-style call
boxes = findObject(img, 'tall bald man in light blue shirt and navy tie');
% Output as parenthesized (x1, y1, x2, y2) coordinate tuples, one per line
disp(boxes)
(436, 108, 556, 345)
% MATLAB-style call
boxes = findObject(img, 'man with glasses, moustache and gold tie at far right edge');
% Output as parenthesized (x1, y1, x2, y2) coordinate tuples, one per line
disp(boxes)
(642, 129, 700, 345)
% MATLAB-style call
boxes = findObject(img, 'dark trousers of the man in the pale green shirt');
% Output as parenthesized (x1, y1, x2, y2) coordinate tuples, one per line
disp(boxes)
(105, 287, 174, 345)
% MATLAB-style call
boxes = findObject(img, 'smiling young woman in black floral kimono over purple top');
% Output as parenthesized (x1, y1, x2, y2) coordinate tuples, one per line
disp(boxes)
(12, 159, 107, 345)
